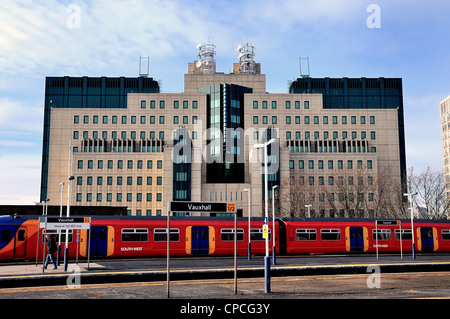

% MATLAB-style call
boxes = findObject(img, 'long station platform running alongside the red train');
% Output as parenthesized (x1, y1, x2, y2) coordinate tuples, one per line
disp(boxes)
(0, 254, 450, 289)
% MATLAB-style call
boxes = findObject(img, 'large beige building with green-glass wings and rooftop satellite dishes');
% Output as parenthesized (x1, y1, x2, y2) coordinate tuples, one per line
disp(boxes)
(41, 44, 406, 217)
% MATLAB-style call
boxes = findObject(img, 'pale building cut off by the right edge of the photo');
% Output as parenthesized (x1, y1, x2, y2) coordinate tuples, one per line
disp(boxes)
(440, 96, 450, 201)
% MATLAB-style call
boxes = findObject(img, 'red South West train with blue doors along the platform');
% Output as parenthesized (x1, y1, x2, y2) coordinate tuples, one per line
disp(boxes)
(0, 216, 450, 261)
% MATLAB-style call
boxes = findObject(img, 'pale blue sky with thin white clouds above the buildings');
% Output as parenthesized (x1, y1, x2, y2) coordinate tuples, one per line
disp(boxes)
(0, 0, 450, 205)
